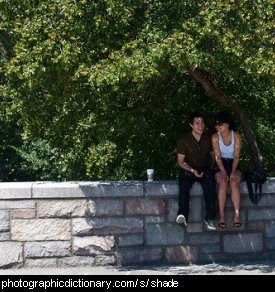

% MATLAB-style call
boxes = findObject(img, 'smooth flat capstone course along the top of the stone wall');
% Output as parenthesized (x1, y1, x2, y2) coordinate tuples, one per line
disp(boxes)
(0, 177, 275, 200)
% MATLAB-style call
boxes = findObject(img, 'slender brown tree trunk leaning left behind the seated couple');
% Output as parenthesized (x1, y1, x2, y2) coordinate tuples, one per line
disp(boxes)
(188, 66, 264, 171)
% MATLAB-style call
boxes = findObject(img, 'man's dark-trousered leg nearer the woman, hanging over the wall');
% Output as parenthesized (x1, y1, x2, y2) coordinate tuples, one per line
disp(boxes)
(199, 169, 217, 220)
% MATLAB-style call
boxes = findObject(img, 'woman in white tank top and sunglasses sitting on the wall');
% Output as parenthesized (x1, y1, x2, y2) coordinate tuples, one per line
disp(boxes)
(212, 112, 242, 228)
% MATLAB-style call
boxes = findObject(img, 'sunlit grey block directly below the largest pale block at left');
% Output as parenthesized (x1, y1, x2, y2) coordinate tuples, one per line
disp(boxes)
(24, 241, 71, 258)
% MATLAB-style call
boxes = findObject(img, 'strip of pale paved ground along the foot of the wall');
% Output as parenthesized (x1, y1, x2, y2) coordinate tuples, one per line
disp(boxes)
(0, 261, 275, 275)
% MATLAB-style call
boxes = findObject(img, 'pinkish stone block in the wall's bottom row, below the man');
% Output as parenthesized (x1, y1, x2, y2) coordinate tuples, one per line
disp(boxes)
(165, 246, 198, 264)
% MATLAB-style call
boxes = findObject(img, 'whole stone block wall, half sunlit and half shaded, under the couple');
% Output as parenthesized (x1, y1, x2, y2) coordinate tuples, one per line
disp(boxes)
(0, 178, 275, 268)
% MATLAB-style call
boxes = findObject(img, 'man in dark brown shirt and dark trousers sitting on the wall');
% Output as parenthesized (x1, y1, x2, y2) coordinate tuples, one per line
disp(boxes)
(176, 113, 216, 230)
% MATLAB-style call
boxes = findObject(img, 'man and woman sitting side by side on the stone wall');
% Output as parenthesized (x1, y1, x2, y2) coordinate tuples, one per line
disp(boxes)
(176, 112, 241, 230)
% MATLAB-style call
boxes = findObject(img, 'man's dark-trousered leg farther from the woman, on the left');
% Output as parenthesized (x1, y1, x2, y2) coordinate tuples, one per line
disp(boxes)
(178, 170, 195, 222)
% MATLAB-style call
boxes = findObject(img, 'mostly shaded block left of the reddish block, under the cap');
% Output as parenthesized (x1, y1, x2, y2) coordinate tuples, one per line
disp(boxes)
(88, 199, 123, 216)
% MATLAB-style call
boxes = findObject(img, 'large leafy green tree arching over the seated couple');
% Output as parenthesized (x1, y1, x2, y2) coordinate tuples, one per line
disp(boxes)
(0, 0, 274, 179)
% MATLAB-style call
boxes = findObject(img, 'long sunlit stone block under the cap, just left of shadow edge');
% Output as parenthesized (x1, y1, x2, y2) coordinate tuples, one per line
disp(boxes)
(37, 200, 87, 218)
